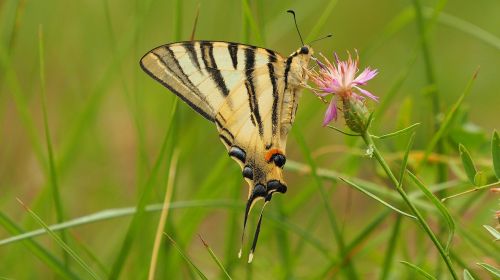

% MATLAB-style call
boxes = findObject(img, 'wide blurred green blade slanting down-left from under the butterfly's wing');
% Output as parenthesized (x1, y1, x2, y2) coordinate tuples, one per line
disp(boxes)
(109, 98, 178, 279)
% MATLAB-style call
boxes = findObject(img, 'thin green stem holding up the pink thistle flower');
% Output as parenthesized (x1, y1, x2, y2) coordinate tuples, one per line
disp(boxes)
(361, 130, 459, 279)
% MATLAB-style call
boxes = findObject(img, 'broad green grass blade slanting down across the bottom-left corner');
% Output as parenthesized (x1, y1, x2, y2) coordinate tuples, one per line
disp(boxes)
(0, 213, 81, 279)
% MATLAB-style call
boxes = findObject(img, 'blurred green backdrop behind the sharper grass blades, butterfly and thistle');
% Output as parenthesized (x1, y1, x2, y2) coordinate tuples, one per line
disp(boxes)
(0, 0, 500, 279)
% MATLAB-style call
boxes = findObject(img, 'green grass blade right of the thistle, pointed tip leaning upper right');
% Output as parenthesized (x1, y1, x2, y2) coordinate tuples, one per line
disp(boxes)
(417, 69, 479, 169)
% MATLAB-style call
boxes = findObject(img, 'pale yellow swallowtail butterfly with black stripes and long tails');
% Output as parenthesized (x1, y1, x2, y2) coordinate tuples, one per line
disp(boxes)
(140, 10, 313, 262)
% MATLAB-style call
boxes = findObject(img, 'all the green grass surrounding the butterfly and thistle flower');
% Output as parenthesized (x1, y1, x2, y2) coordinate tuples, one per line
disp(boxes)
(0, 0, 500, 279)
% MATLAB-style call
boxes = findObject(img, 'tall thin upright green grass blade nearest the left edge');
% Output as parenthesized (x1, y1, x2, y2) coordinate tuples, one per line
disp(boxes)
(38, 25, 69, 266)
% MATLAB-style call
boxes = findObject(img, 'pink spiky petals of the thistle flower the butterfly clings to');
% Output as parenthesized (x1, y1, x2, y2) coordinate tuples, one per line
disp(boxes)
(310, 52, 378, 126)
